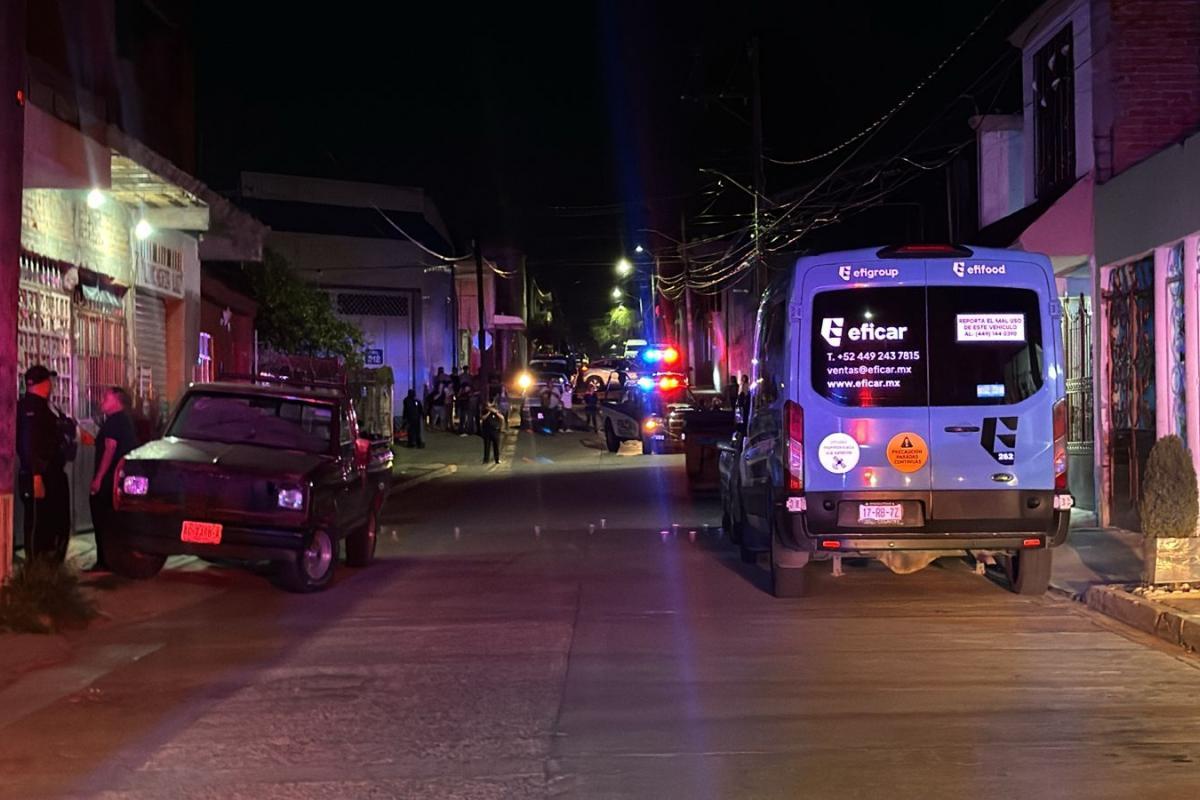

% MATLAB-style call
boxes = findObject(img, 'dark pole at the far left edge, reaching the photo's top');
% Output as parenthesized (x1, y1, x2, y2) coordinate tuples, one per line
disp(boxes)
(0, 0, 25, 584)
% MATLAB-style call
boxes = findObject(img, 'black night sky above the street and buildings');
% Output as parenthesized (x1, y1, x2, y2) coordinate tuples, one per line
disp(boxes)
(196, 0, 1038, 340)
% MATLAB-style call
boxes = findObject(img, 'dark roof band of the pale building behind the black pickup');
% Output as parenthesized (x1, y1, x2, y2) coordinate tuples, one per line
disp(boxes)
(238, 197, 454, 255)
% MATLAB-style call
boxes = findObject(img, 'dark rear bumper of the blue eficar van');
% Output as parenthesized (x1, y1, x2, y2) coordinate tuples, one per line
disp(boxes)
(784, 489, 1070, 552)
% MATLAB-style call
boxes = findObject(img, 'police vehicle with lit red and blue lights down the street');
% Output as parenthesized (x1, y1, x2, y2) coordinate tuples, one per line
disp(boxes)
(598, 372, 692, 455)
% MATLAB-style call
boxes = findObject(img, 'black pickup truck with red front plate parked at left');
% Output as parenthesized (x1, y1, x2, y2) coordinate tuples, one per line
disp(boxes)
(111, 383, 392, 593)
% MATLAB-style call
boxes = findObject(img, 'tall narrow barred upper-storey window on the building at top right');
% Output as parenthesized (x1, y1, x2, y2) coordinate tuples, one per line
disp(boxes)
(1033, 23, 1075, 198)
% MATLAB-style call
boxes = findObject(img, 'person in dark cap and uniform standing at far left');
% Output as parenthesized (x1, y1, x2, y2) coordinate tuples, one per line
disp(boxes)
(17, 363, 71, 564)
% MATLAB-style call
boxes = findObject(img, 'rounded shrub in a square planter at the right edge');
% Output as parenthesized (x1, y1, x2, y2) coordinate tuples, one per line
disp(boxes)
(1141, 435, 1200, 583)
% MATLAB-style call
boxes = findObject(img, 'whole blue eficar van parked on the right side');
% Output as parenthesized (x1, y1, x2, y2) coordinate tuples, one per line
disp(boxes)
(722, 246, 1073, 595)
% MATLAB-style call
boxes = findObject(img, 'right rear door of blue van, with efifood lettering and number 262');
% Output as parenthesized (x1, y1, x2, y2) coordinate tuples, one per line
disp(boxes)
(926, 259, 1057, 530)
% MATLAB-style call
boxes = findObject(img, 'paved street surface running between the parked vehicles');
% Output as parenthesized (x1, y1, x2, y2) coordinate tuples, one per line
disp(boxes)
(0, 434, 1200, 800)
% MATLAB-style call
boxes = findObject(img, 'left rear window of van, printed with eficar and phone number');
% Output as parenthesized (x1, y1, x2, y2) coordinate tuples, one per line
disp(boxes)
(811, 287, 929, 407)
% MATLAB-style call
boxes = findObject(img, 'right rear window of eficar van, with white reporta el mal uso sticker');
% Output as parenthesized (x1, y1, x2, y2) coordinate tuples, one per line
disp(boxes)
(928, 287, 1045, 405)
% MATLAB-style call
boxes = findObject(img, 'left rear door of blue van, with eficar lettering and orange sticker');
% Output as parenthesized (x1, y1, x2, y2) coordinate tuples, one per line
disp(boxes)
(798, 266, 931, 534)
